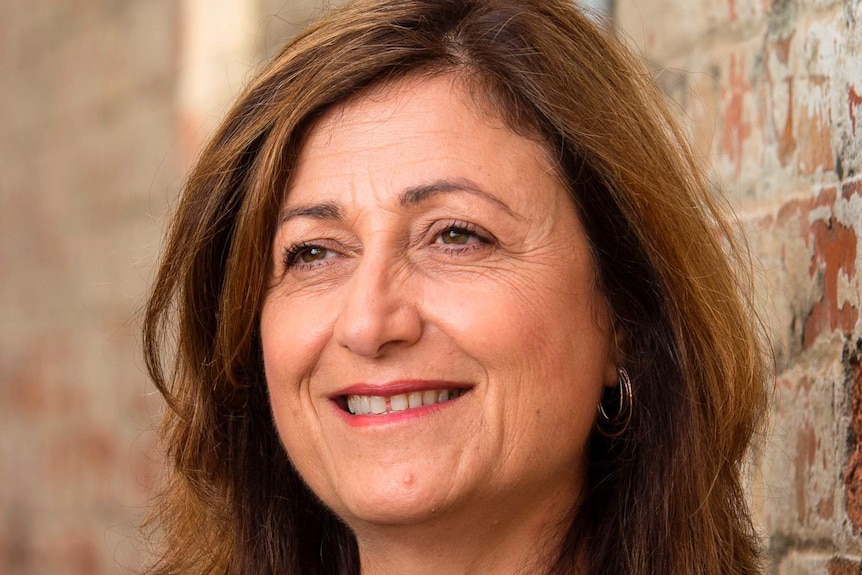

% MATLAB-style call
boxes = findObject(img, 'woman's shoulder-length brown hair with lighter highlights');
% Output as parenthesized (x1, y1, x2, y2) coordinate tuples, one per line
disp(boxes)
(144, 0, 767, 575)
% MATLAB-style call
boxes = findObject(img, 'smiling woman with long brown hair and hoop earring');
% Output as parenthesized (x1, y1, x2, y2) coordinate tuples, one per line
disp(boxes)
(145, 0, 766, 575)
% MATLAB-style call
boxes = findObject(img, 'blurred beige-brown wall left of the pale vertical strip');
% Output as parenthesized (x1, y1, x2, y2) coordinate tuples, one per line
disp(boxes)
(0, 0, 178, 575)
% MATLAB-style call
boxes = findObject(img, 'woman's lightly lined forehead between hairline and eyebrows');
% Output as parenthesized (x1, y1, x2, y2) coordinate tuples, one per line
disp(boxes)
(286, 75, 557, 212)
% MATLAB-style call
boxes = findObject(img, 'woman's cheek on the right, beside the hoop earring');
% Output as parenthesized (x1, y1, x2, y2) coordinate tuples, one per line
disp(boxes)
(426, 274, 611, 432)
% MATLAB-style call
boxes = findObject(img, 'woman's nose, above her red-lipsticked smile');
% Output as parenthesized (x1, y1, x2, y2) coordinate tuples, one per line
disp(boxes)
(334, 254, 422, 358)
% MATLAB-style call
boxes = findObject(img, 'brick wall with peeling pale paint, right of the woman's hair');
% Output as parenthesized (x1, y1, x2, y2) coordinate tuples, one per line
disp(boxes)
(617, 0, 862, 575)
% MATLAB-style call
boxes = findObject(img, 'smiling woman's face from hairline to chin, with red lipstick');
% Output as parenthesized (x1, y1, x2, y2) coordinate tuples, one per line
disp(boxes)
(261, 77, 616, 532)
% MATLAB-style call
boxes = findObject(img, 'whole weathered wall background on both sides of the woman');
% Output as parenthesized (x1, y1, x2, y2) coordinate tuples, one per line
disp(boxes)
(0, 0, 862, 575)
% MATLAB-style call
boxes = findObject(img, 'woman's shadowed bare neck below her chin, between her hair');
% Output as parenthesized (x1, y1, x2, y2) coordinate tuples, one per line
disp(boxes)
(354, 486, 571, 575)
